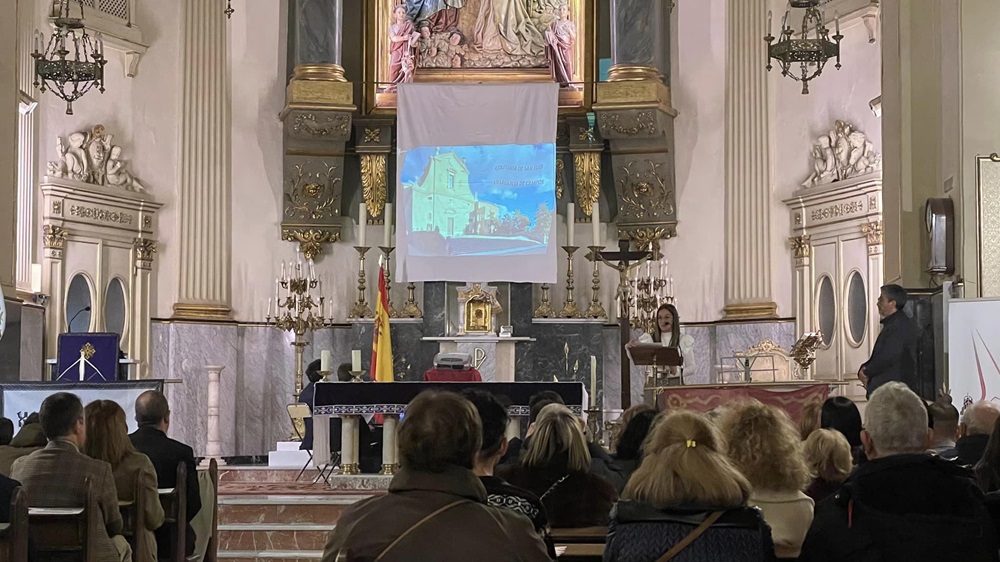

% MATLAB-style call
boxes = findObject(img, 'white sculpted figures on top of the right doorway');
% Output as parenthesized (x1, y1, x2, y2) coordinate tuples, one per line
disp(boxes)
(802, 120, 882, 187)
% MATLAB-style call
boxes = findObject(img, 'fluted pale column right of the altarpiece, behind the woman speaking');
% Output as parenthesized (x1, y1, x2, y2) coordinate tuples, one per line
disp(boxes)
(725, 0, 777, 318)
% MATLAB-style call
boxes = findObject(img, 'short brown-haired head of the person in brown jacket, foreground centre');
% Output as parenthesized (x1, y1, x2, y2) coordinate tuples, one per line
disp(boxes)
(399, 391, 483, 473)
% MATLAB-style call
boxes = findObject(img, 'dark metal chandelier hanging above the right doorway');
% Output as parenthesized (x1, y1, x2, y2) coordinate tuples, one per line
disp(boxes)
(764, 0, 844, 94)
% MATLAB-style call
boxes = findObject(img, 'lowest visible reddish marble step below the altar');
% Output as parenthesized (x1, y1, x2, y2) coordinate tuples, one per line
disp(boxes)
(219, 523, 336, 552)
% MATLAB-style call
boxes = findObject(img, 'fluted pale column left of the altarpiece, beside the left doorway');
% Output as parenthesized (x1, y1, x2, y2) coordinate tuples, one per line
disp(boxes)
(174, 0, 232, 320)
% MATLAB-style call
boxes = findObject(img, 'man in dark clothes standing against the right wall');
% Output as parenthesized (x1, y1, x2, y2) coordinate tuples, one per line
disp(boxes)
(858, 285, 920, 397)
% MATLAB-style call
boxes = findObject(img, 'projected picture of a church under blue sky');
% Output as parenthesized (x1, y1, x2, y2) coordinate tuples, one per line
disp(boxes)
(400, 144, 555, 256)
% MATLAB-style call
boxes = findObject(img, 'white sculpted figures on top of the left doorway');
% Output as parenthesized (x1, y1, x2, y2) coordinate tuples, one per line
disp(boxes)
(47, 125, 146, 192)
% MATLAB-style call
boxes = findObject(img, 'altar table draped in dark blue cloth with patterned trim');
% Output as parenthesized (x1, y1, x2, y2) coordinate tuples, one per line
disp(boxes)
(313, 382, 589, 474)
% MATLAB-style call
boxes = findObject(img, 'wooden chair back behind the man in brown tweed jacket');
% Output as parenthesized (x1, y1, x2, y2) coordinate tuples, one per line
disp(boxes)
(28, 478, 104, 562)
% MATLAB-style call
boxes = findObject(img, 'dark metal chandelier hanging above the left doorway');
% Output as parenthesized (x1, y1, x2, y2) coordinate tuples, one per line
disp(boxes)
(31, 0, 108, 115)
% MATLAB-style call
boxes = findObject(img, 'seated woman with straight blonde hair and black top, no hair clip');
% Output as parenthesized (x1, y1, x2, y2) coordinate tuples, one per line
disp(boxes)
(497, 404, 618, 528)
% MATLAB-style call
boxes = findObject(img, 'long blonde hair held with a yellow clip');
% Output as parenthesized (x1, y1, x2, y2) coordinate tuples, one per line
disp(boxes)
(622, 410, 750, 509)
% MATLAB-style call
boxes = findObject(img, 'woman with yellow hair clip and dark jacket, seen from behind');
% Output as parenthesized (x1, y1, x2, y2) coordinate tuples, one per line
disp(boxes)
(604, 411, 774, 562)
